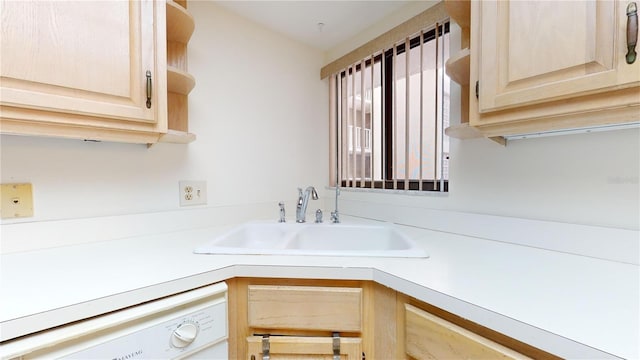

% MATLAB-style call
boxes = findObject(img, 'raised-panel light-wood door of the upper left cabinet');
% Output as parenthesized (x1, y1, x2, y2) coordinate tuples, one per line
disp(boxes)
(0, 0, 166, 130)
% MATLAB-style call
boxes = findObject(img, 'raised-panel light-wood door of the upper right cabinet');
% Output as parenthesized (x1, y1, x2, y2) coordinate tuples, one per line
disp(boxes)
(472, 0, 640, 113)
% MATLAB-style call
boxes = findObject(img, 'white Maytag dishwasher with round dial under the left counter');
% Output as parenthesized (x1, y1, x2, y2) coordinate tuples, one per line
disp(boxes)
(0, 283, 229, 360)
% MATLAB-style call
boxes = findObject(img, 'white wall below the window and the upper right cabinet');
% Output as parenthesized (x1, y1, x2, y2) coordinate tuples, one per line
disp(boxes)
(340, 130, 640, 230)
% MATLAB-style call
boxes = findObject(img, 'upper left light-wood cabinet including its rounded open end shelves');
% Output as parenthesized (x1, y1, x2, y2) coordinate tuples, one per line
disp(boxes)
(0, 0, 195, 144)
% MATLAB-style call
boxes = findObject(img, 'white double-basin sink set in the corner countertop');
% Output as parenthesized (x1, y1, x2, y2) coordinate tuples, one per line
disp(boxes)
(194, 222, 428, 258)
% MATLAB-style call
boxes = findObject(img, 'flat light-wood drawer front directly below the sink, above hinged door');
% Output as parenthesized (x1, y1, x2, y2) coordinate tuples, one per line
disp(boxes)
(247, 285, 362, 332)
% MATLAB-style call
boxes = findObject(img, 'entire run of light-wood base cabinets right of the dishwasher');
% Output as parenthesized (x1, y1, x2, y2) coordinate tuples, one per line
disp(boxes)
(227, 278, 556, 360)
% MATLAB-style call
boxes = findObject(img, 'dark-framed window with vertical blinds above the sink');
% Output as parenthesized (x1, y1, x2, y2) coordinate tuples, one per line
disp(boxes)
(331, 22, 449, 191)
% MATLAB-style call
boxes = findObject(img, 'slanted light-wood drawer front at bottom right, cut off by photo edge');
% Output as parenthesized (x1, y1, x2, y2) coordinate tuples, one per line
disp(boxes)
(405, 304, 529, 359)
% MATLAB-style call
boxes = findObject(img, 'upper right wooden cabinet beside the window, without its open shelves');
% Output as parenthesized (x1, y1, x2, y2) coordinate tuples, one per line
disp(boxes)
(469, 1, 640, 137)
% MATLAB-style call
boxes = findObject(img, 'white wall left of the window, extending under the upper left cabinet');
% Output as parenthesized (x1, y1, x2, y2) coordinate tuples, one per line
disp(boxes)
(0, 1, 328, 224)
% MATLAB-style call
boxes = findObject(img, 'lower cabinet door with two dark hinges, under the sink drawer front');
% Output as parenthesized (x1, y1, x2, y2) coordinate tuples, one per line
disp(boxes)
(247, 336, 362, 360)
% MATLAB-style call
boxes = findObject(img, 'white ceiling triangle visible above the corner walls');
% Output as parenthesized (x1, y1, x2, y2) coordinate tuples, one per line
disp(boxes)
(210, 0, 410, 51)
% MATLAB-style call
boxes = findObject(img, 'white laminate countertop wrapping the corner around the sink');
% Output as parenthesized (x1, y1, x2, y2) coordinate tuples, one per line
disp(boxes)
(0, 218, 640, 359)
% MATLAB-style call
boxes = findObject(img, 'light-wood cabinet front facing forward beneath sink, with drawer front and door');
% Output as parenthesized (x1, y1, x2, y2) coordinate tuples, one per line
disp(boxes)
(229, 279, 364, 360)
